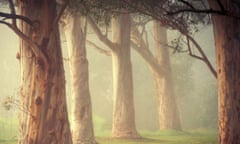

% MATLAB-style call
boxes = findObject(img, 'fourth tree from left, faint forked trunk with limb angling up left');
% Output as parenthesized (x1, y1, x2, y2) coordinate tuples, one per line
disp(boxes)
(132, 21, 181, 130)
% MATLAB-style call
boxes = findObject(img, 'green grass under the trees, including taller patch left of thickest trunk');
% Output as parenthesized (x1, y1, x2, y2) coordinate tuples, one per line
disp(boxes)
(0, 117, 217, 144)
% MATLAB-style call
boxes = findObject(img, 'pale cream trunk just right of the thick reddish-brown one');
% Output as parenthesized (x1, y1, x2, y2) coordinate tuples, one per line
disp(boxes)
(64, 12, 96, 144)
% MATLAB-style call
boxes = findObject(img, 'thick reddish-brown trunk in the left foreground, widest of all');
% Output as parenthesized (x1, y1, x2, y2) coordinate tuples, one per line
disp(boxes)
(18, 0, 72, 144)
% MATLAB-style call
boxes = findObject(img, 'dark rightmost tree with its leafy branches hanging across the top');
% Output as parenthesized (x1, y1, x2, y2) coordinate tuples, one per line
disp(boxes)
(110, 0, 240, 144)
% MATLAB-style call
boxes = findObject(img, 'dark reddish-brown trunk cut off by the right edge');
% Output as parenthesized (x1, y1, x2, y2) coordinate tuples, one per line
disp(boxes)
(209, 0, 240, 144)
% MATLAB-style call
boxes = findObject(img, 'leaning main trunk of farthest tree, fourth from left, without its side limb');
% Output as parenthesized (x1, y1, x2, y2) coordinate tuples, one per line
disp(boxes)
(152, 21, 181, 130)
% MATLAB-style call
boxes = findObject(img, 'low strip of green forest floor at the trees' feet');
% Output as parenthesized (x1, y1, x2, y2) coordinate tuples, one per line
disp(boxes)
(0, 130, 217, 144)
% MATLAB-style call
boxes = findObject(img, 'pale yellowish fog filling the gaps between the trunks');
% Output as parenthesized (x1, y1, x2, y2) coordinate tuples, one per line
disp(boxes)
(0, 21, 217, 138)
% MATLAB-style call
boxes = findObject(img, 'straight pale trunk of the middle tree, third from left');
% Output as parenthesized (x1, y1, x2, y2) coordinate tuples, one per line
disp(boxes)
(112, 14, 139, 138)
